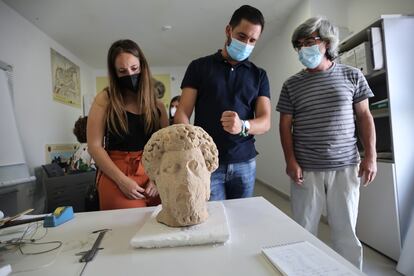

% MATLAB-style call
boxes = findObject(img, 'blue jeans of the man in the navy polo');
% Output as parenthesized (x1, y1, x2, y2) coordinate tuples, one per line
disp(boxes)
(210, 158, 256, 201)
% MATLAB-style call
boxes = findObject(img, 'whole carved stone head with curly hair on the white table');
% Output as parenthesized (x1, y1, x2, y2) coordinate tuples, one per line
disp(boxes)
(142, 124, 218, 227)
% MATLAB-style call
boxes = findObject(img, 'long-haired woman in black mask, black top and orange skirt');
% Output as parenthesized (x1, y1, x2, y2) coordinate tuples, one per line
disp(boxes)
(87, 40, 168, 210)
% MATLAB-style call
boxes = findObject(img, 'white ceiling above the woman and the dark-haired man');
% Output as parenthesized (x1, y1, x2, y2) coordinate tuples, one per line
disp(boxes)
(3, 0, 301, 69)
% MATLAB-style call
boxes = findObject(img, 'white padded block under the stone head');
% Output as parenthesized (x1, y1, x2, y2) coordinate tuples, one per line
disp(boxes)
(130, 201, 230, 248)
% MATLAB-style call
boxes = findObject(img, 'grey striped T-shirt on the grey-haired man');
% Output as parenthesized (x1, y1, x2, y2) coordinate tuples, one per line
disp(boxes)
(276, 63, 374, 170)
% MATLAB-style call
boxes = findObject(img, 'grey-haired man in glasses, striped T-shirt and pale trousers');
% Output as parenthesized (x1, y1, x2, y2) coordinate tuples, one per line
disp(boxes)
(277, 17, 377, 269)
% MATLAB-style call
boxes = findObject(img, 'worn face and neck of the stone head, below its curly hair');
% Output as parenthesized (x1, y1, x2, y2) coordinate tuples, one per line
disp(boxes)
(155, 148, 211, 226)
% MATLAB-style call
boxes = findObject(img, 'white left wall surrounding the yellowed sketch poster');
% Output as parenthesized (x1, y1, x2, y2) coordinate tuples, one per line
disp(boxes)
(0, 1, 94, 169)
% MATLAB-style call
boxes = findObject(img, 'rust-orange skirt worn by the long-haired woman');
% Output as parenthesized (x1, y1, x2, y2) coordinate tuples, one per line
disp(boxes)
(97, 151, 161, 210)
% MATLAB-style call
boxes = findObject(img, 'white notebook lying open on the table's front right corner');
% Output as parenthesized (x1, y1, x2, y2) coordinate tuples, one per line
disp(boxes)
(262, 241, 357, 276)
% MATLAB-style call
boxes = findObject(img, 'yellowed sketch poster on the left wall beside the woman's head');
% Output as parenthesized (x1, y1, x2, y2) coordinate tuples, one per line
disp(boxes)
(50, 48, 81, 108)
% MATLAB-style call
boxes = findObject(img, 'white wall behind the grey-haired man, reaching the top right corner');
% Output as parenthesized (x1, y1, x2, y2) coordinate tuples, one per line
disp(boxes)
(253, 0, 414, 195)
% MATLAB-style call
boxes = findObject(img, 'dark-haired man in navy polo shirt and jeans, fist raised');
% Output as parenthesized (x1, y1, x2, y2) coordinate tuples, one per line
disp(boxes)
(174, 5, 271, 200)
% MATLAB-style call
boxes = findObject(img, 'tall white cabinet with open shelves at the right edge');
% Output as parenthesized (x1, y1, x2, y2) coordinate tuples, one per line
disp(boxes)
(340, 16, 414, 260)
